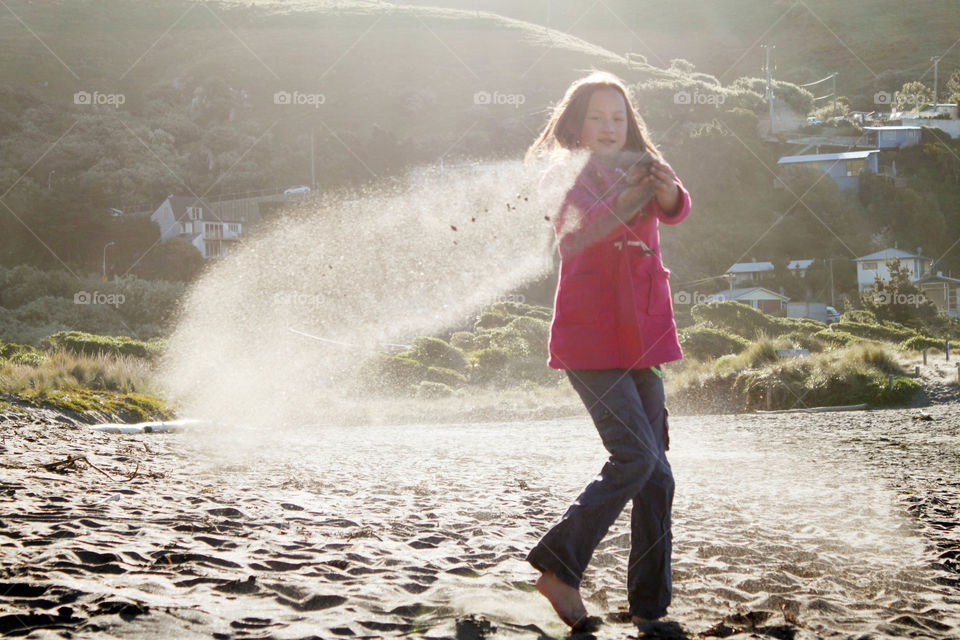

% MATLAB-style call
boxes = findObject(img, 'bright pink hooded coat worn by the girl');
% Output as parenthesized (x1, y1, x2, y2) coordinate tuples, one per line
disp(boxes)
(547, 154, 690, 369)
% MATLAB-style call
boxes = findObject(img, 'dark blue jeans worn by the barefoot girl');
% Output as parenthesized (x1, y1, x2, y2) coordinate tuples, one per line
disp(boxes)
(527, 368, 674, 619)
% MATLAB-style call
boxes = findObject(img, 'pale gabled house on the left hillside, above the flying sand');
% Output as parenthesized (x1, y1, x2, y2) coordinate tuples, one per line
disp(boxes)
(150, 195, 251, 258)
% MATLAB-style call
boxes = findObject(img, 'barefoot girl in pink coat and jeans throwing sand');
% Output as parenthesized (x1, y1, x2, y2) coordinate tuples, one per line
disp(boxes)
(527, 72, 690, 630)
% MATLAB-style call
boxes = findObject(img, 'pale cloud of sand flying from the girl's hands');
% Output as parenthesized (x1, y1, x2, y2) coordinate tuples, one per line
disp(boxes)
(163, 159, 585, 431)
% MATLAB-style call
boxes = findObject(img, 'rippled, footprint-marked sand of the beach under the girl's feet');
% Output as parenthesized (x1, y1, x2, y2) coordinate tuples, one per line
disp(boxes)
(0, 403, 960, 639)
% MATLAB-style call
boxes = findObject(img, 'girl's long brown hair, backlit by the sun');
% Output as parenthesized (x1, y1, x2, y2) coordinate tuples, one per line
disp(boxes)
(526, 71, 662, 162)
